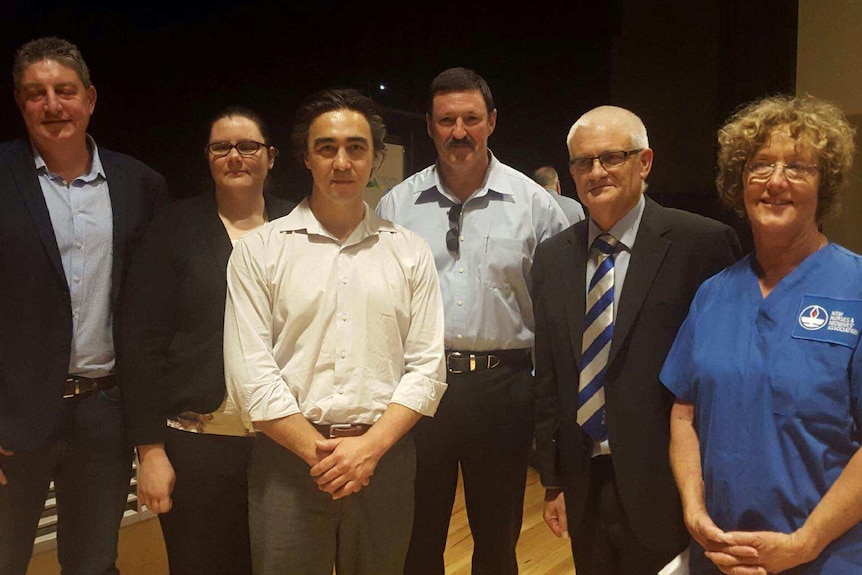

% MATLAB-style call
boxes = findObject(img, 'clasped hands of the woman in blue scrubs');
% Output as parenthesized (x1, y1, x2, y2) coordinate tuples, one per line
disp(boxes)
(686, 511, 816, 575)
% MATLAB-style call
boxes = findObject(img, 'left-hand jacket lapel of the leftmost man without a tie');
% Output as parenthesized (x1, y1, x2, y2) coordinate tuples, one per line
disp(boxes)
(10, 140, 66, 285)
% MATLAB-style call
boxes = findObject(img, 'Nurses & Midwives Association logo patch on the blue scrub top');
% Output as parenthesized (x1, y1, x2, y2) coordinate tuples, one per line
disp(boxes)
(791, 295, 862, 348)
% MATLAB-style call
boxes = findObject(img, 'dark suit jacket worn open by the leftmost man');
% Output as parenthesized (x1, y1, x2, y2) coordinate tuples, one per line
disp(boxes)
(0, 140, 168, 451)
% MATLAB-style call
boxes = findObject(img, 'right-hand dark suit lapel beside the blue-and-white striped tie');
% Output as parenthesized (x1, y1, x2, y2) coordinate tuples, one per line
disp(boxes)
(608, 198, 670, 364)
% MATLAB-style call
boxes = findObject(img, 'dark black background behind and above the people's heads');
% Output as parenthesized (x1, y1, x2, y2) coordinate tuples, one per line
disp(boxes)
(0, 0, 797, 250)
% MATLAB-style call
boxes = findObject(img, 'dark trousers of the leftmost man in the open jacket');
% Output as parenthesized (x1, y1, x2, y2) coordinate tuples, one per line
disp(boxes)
(0, 387, 132, 575)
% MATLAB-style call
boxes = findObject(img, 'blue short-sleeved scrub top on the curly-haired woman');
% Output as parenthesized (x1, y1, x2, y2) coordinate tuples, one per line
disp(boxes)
(660, 244, 862, 574)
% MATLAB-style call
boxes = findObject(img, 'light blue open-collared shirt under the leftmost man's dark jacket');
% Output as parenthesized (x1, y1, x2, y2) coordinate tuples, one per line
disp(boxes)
(33, 136, 114, 377)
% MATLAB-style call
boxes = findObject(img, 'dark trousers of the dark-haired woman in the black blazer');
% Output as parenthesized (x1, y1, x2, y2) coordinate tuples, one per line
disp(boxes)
(159, 428, 254, 575)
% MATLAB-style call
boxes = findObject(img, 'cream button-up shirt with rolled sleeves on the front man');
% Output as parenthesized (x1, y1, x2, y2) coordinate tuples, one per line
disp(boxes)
(224, 200, 446, 425)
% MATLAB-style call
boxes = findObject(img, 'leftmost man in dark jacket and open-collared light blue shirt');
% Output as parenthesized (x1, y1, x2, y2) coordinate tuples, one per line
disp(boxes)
(0, 38, 167, 575)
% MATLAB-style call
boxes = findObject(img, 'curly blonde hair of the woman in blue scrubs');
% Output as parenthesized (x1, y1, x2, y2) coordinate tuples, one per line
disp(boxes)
(715, 96, 856, 223)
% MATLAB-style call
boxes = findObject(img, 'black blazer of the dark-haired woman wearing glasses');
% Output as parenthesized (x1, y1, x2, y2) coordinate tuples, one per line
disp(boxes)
(118, 193, 294, 445)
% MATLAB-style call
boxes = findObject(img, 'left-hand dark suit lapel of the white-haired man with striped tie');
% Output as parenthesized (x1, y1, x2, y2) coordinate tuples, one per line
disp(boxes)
(560, 221, 588, 370)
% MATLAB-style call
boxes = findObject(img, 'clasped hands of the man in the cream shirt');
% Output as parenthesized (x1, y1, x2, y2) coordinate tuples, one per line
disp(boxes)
(311, 435, 381, 499)
